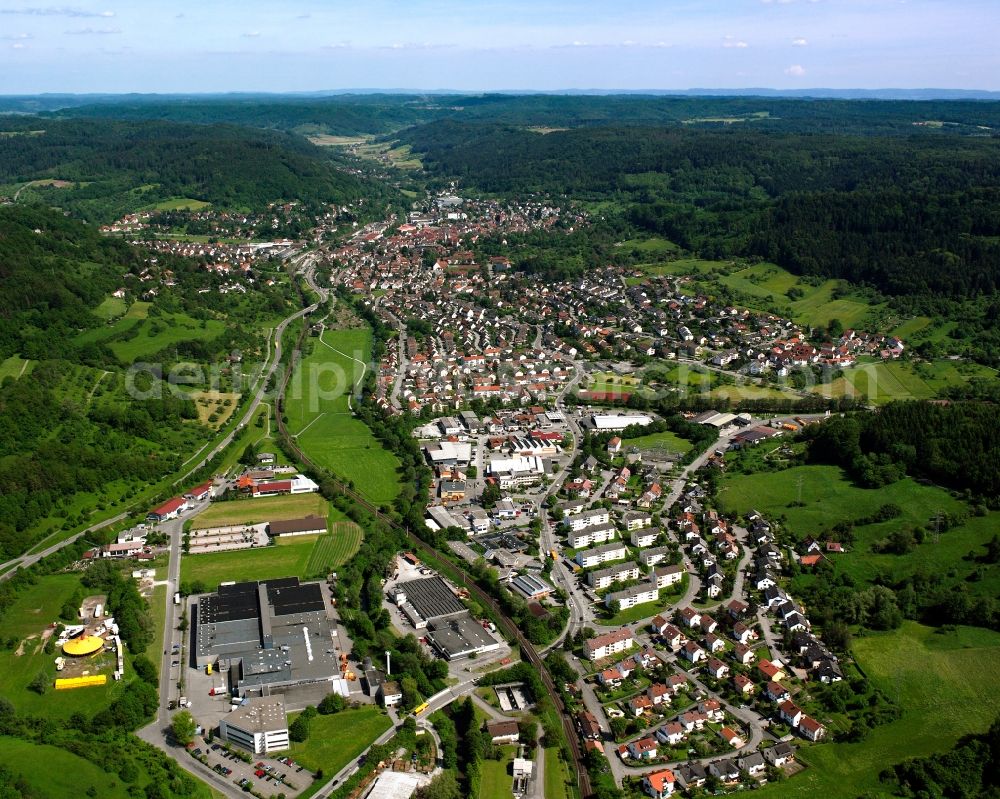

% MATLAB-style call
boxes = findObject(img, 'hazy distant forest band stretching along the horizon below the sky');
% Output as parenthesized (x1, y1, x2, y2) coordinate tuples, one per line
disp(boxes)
(41, 94, 1000, 135)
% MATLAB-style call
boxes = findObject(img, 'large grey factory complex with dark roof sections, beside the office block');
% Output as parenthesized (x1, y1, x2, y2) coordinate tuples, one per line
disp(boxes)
(193, 577, 343, 696)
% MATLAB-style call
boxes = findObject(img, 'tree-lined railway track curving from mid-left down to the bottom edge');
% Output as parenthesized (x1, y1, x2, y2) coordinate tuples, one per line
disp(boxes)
(275, 274, 593, 799)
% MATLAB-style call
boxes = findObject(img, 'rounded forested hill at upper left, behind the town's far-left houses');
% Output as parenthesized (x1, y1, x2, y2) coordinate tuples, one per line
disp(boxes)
(0, 118, 372, 222)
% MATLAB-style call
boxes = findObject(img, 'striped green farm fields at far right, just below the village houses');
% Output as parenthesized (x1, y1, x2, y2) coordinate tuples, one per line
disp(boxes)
(813, 360, 996, 405)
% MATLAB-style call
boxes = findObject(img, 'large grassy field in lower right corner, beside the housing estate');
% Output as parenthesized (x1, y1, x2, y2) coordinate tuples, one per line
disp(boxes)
(759, 622, 1000, 799)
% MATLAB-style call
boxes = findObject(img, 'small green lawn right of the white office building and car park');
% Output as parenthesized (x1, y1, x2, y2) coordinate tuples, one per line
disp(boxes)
(288, 705, 392, 777)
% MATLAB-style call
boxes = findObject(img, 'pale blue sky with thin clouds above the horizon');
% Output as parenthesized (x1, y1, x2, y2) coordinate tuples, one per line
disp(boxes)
(0, 0, 1000, 94)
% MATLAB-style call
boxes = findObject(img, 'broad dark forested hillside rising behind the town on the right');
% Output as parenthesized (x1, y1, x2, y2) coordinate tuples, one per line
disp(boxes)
(402, 120, 1000, 297)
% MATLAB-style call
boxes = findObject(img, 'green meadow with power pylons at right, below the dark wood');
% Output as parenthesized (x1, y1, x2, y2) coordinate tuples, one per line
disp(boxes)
(719, 466, 1000, 595)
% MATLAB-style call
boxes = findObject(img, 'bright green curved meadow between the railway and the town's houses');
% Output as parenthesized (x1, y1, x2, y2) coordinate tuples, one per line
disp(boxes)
(285, 328, 399, 504)
